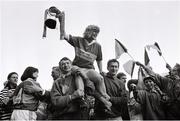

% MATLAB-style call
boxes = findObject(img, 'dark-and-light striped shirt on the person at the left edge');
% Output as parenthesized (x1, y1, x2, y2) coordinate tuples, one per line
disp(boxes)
(0, 88, 15, 120)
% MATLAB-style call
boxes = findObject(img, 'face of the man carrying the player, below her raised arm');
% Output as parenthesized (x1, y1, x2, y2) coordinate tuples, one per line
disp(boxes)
(59, 60, 72, 73)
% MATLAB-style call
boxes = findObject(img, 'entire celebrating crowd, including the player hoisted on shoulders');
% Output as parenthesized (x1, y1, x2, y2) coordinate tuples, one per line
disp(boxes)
(0, 7, 180, 120)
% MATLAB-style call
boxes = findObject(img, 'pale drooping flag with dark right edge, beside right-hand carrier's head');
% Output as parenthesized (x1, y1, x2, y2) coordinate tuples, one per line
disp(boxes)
(123, 60, 135, 77)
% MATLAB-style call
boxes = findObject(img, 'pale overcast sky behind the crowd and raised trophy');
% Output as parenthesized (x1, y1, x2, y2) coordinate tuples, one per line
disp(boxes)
(0, 0, 180, 89)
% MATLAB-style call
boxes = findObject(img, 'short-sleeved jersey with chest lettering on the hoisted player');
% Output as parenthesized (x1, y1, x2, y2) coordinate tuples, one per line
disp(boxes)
(68, 35, 102, 69)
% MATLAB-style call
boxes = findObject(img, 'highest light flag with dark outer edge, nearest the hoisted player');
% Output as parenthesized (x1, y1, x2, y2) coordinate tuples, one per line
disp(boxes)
(115, 39, 127, 59)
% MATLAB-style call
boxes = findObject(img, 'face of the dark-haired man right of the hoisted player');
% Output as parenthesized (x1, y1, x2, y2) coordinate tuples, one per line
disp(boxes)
(107, 62, 119, 76)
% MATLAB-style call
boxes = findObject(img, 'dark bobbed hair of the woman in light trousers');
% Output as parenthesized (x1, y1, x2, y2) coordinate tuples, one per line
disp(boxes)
(21, 66, 38, 81)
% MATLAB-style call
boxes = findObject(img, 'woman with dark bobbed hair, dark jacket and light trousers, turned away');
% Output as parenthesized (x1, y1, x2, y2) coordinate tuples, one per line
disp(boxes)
(11, 67, 49, 120)
